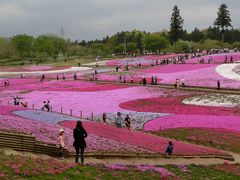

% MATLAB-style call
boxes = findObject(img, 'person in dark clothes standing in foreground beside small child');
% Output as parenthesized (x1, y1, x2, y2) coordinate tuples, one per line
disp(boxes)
(73, 121, 88, 165)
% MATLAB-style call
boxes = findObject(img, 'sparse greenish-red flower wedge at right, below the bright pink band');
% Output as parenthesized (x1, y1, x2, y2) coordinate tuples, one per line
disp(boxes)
(154, 128, 240, 153)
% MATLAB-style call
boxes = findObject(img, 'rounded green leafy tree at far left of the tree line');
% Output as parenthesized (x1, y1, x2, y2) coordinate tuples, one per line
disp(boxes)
(11, 34, 34, 58)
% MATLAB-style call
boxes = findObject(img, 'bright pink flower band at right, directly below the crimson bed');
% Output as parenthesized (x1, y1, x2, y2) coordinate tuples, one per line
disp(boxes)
(144, 115, 240, 131)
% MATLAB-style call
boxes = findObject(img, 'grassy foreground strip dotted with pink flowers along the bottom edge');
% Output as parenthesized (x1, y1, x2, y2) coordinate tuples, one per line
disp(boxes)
(0, 152, 240, 180)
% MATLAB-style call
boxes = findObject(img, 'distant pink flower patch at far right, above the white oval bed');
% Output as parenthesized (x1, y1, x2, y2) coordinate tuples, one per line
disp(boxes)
(186, 52, 240, 63)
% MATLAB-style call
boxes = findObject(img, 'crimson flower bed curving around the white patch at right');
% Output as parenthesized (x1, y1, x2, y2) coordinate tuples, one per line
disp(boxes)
(119, 96, 240, 116)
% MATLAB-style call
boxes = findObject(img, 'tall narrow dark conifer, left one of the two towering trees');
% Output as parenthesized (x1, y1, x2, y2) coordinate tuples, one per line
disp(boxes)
(169, 5, 184, 43)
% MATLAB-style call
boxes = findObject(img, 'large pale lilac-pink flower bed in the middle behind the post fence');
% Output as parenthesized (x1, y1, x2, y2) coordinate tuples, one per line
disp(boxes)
(18, 87, 162, 117)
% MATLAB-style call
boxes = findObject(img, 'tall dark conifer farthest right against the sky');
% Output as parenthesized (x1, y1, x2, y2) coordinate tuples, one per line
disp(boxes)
(214, 4, 232, 44)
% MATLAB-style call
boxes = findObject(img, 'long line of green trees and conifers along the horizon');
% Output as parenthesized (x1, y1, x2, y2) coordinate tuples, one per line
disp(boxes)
(0, 4, 240, 63)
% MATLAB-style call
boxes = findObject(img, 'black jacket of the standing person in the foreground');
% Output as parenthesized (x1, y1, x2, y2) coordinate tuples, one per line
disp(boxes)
(73, 128, 88, 147)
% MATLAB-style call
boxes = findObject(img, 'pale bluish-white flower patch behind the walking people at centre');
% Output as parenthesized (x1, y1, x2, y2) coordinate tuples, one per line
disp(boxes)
(94, 112, 168, 130)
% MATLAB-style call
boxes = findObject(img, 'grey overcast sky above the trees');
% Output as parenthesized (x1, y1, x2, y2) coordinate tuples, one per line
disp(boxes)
(0, 0, 240, 40)
